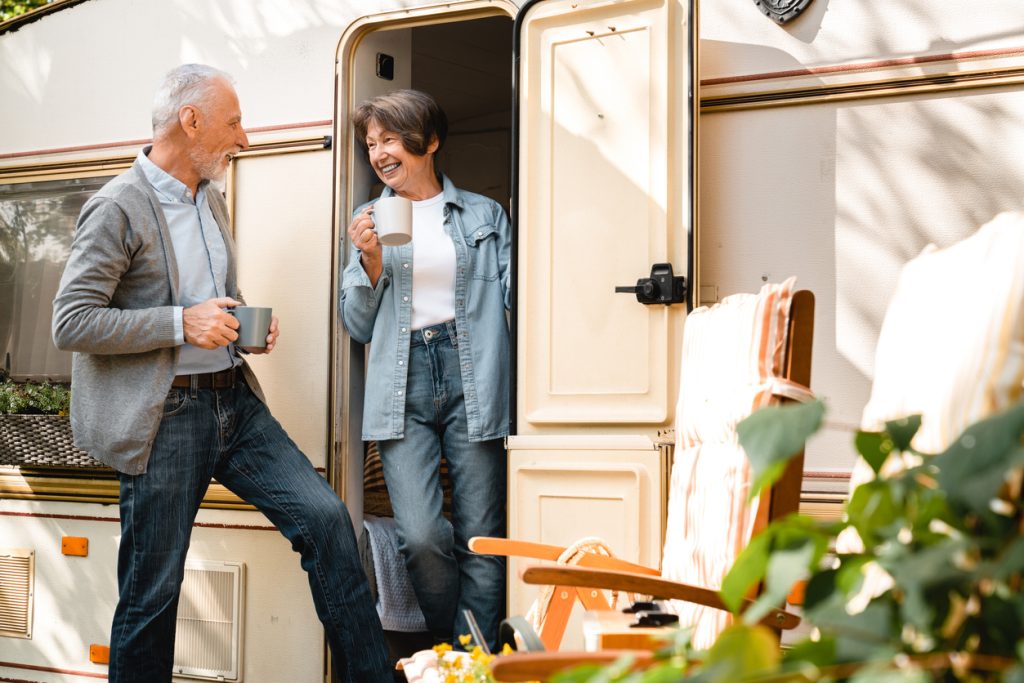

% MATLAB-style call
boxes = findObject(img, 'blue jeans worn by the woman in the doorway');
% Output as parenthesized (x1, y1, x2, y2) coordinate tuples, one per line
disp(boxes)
(371, 322, 506, 648)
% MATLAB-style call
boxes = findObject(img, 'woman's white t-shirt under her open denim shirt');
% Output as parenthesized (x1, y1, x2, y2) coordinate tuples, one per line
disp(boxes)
(412, 194, 456, 330)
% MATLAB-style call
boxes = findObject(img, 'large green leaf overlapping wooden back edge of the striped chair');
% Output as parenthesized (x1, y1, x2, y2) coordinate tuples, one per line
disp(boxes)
(736, 400, 825, 499)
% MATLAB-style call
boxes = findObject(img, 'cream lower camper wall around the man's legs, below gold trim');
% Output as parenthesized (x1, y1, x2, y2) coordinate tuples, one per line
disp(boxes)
(0, 500, 324, 683)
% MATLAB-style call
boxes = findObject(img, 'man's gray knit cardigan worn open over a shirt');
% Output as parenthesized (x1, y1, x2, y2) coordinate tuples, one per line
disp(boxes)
(53, 162, 263, 474)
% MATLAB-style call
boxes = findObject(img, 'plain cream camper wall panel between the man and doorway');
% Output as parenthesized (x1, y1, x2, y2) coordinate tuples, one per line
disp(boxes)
(232, 151, 334, 468)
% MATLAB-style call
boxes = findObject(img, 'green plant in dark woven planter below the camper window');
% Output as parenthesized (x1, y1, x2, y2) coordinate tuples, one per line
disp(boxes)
(0, 370, 99, 467)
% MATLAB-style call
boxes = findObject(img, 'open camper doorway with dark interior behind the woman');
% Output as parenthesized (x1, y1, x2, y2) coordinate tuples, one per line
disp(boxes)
(332, 2, 515, 657)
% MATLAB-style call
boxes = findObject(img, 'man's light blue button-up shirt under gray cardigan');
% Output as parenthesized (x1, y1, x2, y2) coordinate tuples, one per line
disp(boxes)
(138, 146, 234, 375)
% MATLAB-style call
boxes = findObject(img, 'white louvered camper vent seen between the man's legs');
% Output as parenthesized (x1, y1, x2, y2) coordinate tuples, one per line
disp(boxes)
(174, 560, 245, 681)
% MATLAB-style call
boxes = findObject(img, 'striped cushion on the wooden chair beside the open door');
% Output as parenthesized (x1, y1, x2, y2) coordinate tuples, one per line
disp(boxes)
(662, 278, 796, 648)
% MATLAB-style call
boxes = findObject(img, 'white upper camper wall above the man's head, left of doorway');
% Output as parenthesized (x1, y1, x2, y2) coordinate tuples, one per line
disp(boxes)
(0, 0, 452, 155)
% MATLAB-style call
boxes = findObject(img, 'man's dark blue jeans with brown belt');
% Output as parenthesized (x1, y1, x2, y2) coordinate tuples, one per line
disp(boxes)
(110, 379, 392, 683)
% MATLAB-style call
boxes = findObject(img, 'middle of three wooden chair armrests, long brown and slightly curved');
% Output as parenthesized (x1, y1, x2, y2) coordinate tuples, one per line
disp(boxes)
(522, 566, 800, 629)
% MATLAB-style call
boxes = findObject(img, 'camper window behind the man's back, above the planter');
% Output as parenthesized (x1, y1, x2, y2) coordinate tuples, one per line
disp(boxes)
(0, 176, 110, 381)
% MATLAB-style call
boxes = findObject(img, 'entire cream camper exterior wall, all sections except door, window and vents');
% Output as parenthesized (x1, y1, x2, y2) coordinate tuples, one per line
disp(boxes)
(0, 0, 1024, 683)
